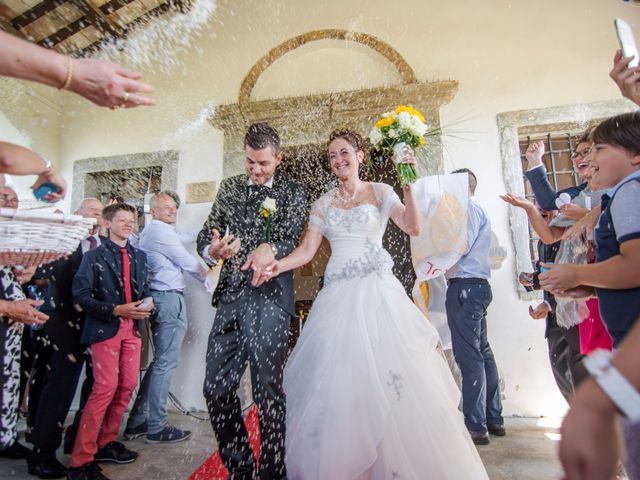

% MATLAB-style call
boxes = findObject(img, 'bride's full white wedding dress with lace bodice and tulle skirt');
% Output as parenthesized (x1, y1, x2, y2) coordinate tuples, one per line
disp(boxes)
(284, 184, 488, 480)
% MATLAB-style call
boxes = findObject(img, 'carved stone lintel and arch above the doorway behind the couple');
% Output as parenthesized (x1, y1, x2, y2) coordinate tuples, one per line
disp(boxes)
(210, 29, 458, 177)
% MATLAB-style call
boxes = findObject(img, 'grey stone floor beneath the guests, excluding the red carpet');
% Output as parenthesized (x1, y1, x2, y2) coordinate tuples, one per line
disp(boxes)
(0, 414, 560, 480)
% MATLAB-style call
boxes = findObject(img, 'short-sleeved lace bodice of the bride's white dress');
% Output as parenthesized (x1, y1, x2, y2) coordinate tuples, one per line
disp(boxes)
(309, 183, 402, 285)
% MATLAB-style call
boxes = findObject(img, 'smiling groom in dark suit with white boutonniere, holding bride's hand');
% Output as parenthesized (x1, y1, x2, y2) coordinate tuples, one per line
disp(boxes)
(198, 123, 307, 480)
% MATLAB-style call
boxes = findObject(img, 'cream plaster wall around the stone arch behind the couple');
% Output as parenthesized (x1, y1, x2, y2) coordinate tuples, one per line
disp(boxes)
(6, 0, 640, 415)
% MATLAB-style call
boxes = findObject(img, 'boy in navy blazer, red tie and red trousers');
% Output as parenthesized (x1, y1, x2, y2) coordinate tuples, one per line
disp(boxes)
(68, 203, 153, 480)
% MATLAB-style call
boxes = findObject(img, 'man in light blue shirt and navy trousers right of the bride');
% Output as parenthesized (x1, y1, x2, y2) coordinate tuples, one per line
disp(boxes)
(445, 168, 506, 445)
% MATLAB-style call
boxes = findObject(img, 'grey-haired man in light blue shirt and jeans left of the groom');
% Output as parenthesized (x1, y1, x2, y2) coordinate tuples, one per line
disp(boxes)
(125, 192, 207, 443)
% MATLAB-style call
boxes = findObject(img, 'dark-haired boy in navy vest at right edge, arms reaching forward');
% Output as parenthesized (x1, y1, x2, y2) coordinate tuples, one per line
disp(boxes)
(540, 111, 640, 479)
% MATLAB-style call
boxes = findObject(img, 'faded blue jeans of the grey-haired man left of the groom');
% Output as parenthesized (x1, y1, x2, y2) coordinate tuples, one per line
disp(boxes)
(127, 292, 187, 434)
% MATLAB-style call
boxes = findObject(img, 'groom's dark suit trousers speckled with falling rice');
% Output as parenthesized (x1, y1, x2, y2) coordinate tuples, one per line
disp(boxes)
(203, 287, 290, 480)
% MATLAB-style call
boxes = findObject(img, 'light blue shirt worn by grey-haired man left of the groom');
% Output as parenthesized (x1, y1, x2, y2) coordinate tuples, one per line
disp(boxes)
(138, 220, 207, 291)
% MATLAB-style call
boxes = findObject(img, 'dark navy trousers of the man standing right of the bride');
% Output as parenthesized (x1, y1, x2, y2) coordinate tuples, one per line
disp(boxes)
(446, 278, 504, 432)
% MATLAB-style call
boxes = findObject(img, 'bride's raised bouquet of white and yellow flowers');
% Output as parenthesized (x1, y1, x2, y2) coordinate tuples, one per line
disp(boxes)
(369, 105, 429, 186)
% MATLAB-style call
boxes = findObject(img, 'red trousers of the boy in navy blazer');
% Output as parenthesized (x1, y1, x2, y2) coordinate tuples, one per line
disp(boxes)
(71, 320, 141, 467)
